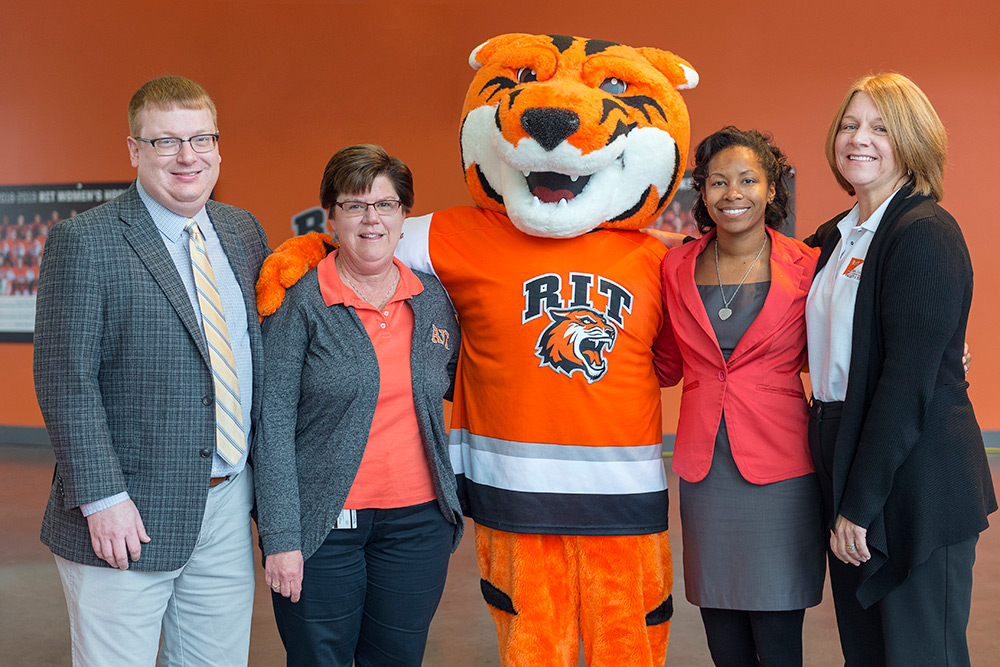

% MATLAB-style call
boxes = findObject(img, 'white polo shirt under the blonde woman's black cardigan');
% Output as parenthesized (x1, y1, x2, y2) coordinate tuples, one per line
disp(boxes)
(806, 190, 898, 401)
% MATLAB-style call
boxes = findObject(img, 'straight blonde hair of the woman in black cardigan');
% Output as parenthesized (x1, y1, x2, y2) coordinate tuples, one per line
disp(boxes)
(826, 72, 948, 201)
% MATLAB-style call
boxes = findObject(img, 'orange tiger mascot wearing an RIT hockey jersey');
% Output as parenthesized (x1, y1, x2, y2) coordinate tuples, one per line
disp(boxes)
(258, 34, 697, 667)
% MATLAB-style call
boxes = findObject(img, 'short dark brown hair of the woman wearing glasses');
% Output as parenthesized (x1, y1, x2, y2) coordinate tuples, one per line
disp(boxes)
(319, 144, 413, 218)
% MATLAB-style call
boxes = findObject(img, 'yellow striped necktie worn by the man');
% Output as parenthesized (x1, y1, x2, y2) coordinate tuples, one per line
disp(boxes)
(184, 220, 246, 465)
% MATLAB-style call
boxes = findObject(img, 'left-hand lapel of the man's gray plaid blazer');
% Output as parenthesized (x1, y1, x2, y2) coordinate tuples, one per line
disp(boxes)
(119, 183, 211, 366)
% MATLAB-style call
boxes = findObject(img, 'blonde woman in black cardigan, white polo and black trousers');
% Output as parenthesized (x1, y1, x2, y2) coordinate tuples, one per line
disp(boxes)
(806, 74, 997, 666)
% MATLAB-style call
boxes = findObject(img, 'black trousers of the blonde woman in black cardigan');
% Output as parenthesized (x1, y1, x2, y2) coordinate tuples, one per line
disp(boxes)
(809, 399, 979, 667)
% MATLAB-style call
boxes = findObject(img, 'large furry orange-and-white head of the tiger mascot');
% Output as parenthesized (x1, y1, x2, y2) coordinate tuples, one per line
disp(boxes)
(461, 34, 698, 237)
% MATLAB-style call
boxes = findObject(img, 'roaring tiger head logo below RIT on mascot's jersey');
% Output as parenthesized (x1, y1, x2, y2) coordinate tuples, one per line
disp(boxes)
(535, 308, 618, 384)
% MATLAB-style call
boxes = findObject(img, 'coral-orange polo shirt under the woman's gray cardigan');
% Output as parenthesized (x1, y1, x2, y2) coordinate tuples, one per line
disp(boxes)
(316, 251, 437, 510)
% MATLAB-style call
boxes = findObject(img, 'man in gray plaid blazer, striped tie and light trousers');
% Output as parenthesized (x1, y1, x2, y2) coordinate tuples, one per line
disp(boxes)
(34, 76, 268, 667)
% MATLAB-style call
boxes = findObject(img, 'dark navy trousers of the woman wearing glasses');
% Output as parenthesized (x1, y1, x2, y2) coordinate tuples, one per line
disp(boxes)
(271, 500, 455, 667)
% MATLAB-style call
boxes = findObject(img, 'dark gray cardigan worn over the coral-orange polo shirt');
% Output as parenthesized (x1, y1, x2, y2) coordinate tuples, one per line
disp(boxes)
(254, 270, 464, 558)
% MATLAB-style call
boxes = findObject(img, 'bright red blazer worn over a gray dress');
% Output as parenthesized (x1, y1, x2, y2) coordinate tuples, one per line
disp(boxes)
(654, 229, 819, 484)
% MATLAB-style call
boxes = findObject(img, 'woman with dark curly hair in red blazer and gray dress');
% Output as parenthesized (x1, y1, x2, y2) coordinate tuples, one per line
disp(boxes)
(656, 127, 825, 666)
